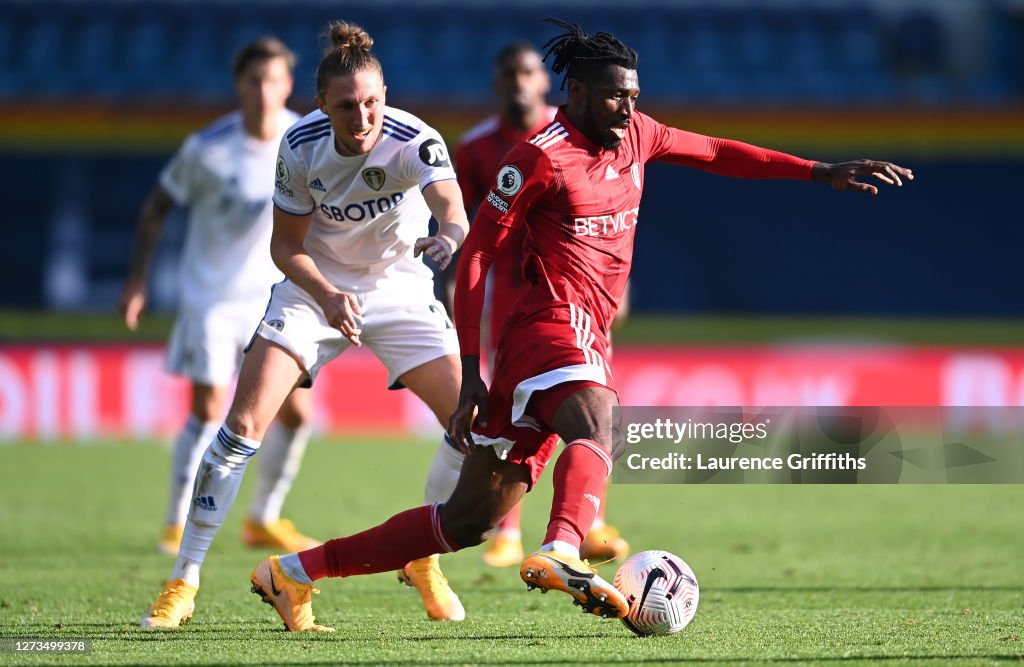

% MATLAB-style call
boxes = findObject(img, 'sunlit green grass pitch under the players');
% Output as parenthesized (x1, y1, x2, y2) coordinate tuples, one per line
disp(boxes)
(0, 439, 1024, 665)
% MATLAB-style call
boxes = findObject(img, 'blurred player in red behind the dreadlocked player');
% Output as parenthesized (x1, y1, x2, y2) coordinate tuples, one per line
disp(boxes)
(444, 42, 630, 568)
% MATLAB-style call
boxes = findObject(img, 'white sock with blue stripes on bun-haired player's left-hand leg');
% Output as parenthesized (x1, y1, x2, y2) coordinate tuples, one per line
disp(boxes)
(171, 425, 260, 586)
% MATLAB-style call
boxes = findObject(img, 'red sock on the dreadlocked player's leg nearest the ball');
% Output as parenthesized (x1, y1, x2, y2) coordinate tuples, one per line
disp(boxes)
(544, 439, 611, 547)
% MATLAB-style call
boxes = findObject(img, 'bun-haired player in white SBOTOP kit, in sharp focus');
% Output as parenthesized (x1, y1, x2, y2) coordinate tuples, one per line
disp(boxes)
(142, 22, 469, 630)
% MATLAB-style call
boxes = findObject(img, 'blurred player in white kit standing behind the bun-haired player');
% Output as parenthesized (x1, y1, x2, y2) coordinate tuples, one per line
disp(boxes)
(121, 37, 318, 565)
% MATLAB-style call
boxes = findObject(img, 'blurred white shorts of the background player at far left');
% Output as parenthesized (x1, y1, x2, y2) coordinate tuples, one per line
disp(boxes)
(166, 300, 266, 386)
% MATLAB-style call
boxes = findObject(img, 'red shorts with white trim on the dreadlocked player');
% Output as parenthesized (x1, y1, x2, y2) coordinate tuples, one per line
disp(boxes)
(473, 306, 615, 483)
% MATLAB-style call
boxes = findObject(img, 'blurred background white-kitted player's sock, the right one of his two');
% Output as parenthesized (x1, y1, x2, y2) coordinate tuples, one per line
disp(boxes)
(249, 420, 309, 524)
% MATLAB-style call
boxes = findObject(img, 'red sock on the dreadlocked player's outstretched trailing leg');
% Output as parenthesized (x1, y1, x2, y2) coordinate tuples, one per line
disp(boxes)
(299, 503, 462, 581)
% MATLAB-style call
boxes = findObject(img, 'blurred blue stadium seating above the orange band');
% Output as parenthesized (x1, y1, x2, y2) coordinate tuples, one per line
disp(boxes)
(0, 0, 1022, 106)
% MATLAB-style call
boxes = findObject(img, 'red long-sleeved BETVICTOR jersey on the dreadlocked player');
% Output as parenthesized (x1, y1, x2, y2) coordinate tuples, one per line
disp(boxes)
(455, 108, 814, 355)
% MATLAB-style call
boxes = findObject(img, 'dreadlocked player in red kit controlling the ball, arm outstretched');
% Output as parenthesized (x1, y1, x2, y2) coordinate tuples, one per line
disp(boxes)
(251, 15, 912, 630)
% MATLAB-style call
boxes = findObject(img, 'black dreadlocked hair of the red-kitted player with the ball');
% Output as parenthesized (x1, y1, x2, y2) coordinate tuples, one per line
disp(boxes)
(544, 16, 637, 89)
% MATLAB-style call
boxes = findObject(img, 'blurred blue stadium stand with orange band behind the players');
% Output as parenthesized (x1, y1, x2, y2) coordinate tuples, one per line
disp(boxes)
(0, 0, 1024, 317)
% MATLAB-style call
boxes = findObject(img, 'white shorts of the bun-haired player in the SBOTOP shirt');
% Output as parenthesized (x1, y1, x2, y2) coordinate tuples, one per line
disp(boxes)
(256, 280, 459, 388)
